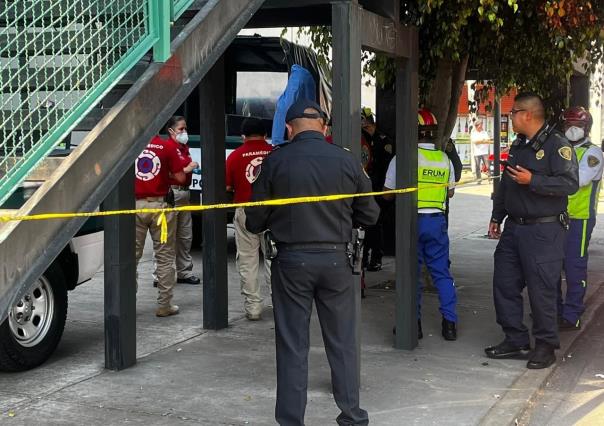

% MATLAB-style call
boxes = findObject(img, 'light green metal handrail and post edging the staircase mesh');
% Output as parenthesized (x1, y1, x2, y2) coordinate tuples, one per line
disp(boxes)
(0, 0, 193, 204)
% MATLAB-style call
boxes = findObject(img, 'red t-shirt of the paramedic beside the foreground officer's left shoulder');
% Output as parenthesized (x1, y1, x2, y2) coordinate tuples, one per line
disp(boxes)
(226, 139, 273, 203)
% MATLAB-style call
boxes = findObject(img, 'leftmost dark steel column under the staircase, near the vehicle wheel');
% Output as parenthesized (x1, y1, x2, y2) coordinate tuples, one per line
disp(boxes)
(102, 168, 136, 370)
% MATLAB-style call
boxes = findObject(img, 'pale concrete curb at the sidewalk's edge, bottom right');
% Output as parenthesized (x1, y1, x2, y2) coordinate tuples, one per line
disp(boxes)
(479, 282, 604, 426)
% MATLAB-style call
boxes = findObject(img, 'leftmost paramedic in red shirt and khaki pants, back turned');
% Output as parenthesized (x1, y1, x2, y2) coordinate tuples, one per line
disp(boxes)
(134, 136, 186, 317)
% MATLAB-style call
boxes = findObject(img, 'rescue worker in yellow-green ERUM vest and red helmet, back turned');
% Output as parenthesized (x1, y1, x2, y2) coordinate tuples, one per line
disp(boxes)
(384, 108, 457, 340)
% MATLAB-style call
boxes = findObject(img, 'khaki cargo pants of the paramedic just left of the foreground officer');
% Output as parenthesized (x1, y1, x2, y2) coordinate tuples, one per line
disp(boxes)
(233, 208, 271, 315)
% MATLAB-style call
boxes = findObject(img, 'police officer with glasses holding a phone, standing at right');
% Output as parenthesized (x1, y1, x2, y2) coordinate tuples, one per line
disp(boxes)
(485, 93, 579, 369)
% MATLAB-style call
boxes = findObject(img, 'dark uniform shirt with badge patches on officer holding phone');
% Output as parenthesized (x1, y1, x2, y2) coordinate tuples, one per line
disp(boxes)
(492, 128, 579, 223)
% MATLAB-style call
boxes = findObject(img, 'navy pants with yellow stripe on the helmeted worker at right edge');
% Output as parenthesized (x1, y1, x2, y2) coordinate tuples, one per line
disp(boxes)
(558, 218, 596, 323)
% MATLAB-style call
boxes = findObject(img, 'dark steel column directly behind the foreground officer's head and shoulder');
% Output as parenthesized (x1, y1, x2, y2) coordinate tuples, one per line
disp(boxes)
(331, 1, 361, 382)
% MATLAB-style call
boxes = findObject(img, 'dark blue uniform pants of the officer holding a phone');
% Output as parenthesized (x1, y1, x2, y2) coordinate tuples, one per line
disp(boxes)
(493, 219, 566, 347)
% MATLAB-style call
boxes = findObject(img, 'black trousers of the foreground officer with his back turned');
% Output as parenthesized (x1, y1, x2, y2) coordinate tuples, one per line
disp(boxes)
(271, 248, 369, 426)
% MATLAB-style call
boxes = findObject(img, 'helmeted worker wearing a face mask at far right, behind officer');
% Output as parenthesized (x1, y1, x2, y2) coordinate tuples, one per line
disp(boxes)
(558, 107, 604, 331)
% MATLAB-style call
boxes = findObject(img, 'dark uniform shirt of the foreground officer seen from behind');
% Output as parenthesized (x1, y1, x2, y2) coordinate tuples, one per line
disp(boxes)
(245, 131, 379, 243)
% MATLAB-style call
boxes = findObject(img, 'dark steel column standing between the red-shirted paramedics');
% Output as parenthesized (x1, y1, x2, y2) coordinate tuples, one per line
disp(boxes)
(199, 57, 229, 330)
